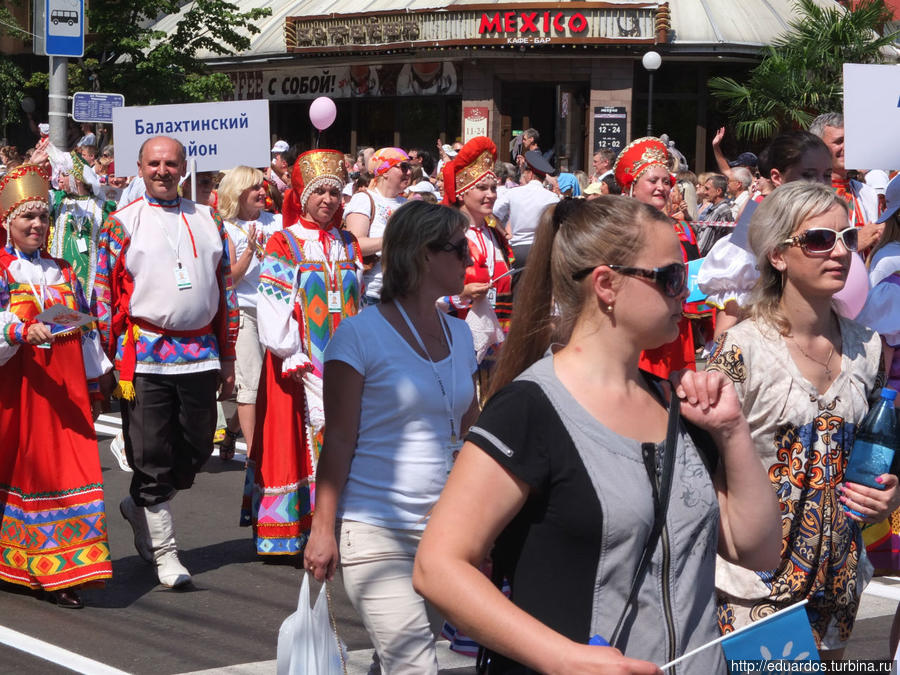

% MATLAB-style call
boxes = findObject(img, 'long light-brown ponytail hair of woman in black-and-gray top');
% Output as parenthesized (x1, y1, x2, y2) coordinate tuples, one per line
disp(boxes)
(488, 195, 671, 396)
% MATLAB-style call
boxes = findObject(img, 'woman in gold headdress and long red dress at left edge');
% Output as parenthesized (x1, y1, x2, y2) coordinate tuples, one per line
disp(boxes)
(0, 165, 112, 609)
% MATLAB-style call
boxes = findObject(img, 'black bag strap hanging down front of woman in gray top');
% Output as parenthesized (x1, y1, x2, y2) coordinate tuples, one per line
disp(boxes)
(609, 391, 681, 648)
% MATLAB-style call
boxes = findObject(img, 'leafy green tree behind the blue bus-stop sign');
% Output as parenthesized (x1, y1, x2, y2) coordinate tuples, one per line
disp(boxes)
(29, 0, 272, 105)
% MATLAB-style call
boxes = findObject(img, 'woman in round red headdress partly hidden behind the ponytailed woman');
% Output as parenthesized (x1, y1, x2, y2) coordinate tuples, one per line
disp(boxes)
(613, 136, 700, 378)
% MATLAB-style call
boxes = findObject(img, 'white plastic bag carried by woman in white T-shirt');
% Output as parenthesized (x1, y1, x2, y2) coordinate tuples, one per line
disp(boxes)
(277, 574, 345, 675)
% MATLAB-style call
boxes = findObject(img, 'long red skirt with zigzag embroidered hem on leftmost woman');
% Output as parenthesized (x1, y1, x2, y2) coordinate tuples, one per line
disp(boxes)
(0, 333, 112, 590)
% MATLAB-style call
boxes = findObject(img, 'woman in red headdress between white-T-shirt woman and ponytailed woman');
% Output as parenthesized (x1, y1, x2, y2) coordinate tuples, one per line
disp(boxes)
(443, 136, 512, 392)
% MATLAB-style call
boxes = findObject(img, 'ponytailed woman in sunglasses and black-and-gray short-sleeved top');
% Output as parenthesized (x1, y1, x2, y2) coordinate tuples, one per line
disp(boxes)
(413, 197, 780, 674)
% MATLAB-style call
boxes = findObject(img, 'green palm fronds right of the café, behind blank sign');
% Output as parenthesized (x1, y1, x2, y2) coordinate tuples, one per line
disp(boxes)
(708, 0, 898, 141)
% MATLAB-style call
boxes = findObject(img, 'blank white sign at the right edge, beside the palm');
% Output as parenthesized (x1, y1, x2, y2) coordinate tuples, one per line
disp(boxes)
(844, 63, 900, 171)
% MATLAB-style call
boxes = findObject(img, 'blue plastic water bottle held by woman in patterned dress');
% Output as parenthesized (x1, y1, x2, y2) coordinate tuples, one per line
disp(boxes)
(844, 387, 897, 515)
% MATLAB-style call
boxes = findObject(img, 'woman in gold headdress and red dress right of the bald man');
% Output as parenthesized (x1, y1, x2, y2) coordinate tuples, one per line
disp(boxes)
(241, 150, 362, 555)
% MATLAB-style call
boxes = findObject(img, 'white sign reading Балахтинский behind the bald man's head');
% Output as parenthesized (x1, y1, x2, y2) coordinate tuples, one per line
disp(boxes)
(113, 101, 270, 176)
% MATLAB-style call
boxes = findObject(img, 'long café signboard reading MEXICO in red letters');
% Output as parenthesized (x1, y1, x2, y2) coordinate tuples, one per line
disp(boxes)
(284, 2, 670, 53)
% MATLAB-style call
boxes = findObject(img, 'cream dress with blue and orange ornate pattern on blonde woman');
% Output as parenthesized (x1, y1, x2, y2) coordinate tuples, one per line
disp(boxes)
(708, 318, 883, 649)
